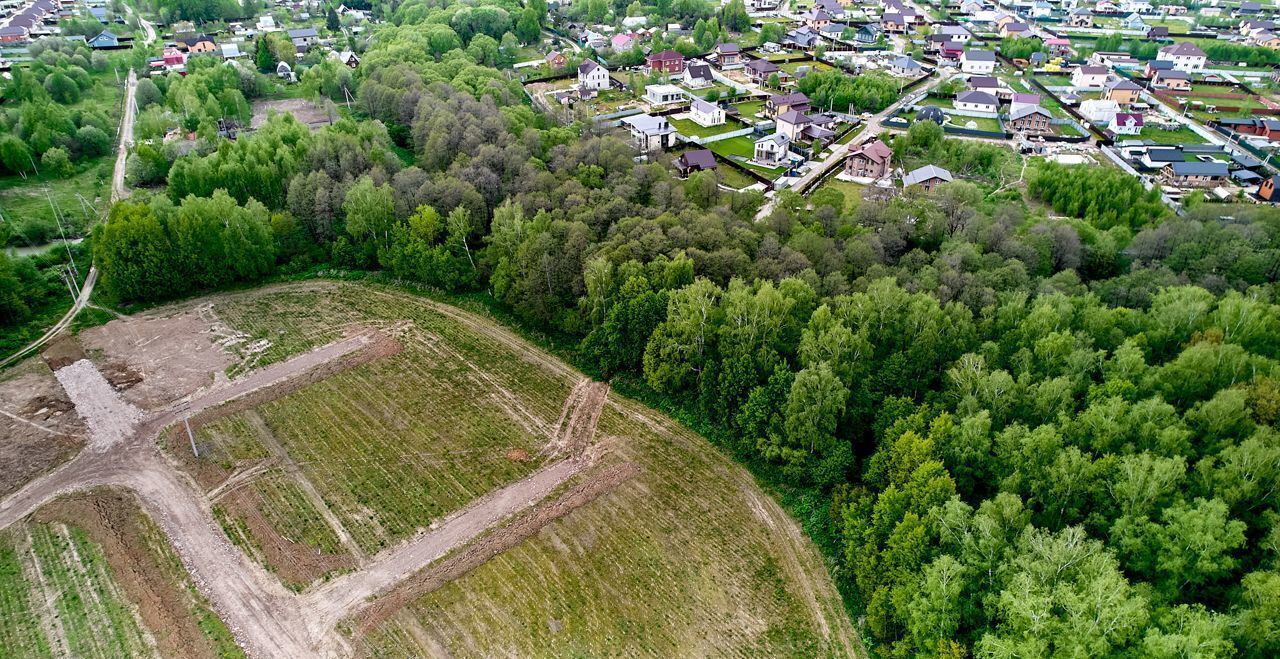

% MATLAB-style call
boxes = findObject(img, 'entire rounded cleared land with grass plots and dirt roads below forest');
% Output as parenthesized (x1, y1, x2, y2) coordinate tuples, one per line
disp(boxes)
(0, 283, 861, 656)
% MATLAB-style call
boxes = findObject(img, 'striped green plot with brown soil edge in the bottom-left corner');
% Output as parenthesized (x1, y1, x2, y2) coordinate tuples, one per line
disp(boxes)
(0, 490, 243, 658)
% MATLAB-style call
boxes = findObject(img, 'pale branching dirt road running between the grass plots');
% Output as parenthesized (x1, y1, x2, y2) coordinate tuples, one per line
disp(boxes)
(0, 333, 608, 658)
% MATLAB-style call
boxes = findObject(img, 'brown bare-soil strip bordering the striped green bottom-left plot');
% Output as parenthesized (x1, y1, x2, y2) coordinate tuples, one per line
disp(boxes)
(35, 489, 231, 658)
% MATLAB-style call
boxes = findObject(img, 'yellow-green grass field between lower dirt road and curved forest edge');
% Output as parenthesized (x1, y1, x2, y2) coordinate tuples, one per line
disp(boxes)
(356, 399, 860, 656)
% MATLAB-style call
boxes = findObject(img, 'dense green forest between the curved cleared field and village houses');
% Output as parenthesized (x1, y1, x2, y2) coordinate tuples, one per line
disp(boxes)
(74, 3, 1280, 658)
